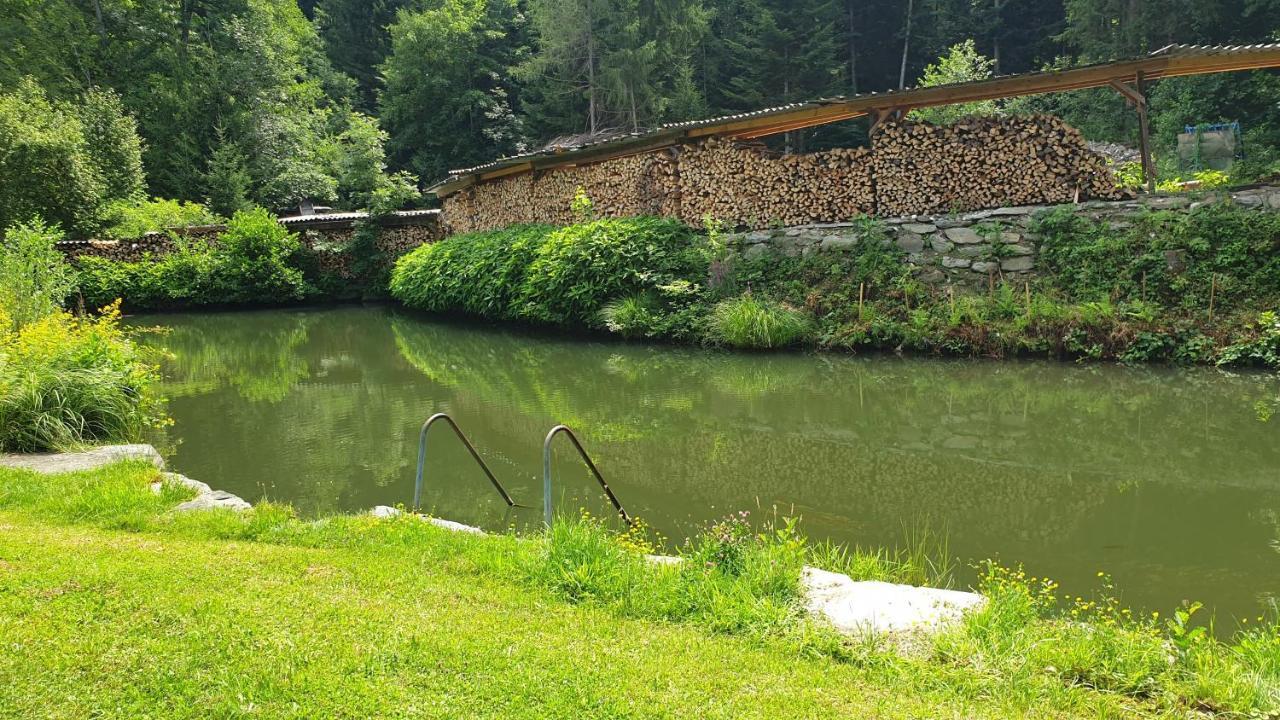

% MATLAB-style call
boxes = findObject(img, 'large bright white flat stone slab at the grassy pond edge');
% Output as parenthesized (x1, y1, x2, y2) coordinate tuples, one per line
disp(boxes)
(801, 568, 986, 633)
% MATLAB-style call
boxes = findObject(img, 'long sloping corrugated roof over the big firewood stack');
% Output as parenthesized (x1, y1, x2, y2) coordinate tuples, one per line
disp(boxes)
(429, 44, 1280, 196)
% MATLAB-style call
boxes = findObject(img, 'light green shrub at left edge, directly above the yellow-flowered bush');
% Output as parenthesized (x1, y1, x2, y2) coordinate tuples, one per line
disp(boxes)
(0, 219, 76, 332)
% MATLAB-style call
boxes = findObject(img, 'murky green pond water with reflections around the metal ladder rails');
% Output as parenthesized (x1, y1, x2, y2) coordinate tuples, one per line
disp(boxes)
(131, 306, 1280, 621)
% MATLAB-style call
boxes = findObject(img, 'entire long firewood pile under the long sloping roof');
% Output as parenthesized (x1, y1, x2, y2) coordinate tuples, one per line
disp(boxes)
(444, 115, 1130, 233)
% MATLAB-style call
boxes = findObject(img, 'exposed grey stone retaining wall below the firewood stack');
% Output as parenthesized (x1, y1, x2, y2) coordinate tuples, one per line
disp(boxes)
(726, 187, 1280, 286)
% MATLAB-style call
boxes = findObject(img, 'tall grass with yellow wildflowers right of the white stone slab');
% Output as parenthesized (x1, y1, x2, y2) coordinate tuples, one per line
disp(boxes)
(934, 562, 1280, 717)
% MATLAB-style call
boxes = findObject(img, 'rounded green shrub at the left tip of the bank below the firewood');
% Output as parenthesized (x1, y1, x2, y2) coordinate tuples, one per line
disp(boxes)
(390, 225, 553, 319)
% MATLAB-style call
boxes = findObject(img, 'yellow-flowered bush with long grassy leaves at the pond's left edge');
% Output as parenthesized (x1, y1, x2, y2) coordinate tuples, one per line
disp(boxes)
(0, 301, 163, 452)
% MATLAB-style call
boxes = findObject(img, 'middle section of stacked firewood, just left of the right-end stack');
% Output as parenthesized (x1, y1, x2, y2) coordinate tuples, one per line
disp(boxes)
(680, 138, 876, 228)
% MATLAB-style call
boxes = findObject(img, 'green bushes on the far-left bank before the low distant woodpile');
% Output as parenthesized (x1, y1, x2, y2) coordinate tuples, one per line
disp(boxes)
(78, 208, 311, 309)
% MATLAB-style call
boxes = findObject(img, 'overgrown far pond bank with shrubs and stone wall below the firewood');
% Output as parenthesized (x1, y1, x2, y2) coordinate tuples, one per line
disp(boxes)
(390, 198, 1280, 368)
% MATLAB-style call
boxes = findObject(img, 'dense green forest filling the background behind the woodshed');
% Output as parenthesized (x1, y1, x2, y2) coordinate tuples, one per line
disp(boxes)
(0, 0, 1280, 234)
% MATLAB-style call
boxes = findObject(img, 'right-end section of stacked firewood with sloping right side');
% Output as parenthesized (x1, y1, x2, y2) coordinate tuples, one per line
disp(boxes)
(872, 115, 1128, 217)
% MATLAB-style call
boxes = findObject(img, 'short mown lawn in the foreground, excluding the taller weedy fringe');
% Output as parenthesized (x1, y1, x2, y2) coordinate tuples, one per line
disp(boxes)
(0, 465, 1187, 717)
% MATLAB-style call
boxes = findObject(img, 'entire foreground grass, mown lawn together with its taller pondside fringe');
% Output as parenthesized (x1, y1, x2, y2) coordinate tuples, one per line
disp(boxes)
(0, 464, 1280, 717)
